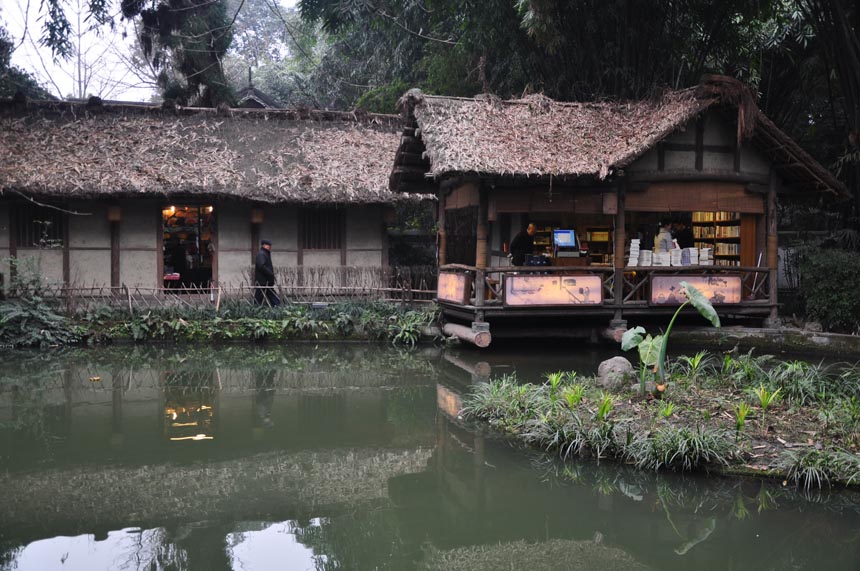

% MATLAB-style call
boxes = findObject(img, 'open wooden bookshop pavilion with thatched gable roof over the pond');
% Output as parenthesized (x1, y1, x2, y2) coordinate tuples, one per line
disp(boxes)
(390, 76, 846, 343)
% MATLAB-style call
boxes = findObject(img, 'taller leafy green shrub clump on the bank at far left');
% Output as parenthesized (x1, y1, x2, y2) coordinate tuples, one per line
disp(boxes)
(0, 258, 80, 347)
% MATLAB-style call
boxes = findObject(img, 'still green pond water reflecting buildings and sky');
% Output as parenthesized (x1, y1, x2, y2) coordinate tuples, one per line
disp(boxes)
(0, 344, 860, 571)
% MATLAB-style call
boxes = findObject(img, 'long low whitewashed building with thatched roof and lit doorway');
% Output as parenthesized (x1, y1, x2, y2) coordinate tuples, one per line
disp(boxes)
(0, 100, 416, 290)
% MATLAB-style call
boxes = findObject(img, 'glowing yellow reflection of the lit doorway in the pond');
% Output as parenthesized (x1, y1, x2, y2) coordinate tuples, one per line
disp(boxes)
(162, 371, 218, 441)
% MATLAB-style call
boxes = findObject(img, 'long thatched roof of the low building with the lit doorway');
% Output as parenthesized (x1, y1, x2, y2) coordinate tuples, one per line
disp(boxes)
(0, 102, 414, 203)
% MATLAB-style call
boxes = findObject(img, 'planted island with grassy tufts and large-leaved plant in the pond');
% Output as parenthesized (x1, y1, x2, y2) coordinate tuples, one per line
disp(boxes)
(462, 284, 860, 488)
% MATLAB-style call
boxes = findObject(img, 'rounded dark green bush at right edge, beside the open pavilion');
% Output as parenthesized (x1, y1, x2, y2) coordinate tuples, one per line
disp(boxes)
(799, 248, 860, 332)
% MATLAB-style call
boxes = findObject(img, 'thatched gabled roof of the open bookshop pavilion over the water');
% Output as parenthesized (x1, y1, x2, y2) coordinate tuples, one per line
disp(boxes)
(390, 76, 844, 197)
